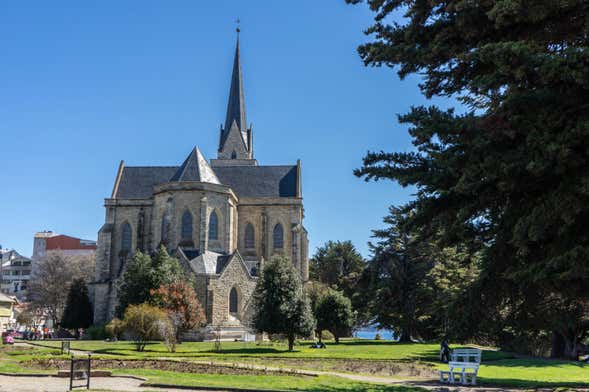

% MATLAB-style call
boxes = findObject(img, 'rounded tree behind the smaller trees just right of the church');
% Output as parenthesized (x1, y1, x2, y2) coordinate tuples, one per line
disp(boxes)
(309, 241, 364, 298)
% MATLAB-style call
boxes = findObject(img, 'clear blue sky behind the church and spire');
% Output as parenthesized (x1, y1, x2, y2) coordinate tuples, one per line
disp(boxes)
(0, 0, 446, 256)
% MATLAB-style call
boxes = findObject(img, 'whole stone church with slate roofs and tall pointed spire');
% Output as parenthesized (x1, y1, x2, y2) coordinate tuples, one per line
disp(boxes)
(92, 38, 309, 336)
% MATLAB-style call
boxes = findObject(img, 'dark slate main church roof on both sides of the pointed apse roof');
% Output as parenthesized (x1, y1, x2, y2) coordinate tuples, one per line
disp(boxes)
(115, 165, 297, 199)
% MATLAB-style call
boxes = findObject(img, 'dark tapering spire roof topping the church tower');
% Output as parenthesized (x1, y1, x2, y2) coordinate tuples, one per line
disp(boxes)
(219, 36, 248, 149)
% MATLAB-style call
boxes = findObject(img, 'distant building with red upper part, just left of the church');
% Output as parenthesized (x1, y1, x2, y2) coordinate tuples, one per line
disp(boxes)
(32, 231, 96, 261)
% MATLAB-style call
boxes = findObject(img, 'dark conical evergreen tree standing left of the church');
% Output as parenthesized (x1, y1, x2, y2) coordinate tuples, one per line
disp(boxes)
(61, 278, 93, 330)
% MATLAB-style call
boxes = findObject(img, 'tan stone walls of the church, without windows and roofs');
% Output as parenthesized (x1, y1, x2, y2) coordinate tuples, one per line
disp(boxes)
(94, 183, 308, 324)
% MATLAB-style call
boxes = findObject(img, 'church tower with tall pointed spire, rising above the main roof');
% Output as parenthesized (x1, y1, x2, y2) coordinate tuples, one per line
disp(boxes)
(211, 35, 257, 166)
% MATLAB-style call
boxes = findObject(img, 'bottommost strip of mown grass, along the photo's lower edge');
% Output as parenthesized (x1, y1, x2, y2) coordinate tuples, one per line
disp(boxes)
(114, 369, 426, 392)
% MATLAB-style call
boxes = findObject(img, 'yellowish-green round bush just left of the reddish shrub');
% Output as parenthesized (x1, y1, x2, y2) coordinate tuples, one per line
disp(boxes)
(123, 303, 169, 351)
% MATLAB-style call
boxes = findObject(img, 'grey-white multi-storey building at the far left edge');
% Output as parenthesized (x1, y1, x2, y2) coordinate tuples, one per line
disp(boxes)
(0, 249, 31, 300)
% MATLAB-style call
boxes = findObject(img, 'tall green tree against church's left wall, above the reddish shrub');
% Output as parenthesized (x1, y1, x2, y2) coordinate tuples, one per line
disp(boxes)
(116, 246, 185, 317)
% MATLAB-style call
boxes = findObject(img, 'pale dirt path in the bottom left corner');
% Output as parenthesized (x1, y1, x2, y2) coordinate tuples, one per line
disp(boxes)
(0, 375, 225, 392)
